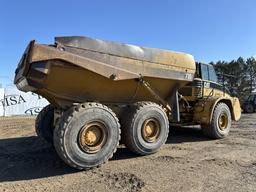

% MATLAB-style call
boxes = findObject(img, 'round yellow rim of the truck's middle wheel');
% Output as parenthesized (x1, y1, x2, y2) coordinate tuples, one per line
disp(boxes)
(142, 118, 160, 143)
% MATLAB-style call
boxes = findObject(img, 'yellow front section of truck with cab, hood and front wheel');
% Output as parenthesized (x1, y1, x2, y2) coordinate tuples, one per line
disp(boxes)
(178, 63, 241, 138)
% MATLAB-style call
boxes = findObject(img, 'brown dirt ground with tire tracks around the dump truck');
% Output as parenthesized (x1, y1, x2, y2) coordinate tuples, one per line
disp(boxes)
(0, 114, 256, 192)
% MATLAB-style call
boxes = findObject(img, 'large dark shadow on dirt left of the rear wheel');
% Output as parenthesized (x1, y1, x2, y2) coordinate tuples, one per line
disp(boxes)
(0, 136, 76, 182)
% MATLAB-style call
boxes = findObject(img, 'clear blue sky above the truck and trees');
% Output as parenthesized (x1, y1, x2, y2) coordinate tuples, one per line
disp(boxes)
(0, 0, 256, 87)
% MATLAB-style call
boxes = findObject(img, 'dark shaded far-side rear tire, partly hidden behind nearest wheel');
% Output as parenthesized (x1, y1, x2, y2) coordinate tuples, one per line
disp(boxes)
(35, 105, 54, 143)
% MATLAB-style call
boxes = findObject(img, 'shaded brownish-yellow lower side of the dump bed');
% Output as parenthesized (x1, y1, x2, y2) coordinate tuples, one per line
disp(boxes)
(34, 60, 187, 108)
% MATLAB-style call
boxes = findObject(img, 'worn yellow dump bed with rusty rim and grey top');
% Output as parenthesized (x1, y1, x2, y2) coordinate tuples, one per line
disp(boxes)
(15, 37, 195, 107)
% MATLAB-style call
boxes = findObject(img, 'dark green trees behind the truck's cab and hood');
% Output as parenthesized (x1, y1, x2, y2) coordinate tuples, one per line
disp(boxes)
(210, 57, 256, 102)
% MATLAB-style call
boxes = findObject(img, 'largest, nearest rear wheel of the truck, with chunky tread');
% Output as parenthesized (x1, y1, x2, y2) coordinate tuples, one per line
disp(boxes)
(54, 103, 121, 169)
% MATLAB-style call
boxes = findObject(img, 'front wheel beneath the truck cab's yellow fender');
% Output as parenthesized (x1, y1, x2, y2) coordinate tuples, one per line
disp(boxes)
(202, 103, 231, 139)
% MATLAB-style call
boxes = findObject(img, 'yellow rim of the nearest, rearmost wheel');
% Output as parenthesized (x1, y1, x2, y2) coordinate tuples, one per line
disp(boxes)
(78, 122, 107, 153)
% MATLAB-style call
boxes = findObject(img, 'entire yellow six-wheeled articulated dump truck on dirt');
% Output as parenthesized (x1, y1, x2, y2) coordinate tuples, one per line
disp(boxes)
(14, 37, 241, 169)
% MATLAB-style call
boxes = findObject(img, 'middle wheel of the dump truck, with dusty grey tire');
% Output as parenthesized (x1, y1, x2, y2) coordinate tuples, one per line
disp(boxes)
(121, 102, 169, 155)
